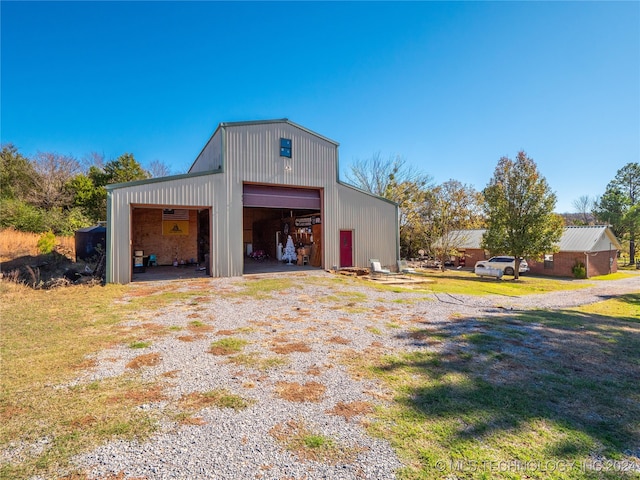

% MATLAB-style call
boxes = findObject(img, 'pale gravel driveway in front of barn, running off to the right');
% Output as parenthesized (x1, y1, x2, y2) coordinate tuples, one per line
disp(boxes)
(67, 273, 640, 479)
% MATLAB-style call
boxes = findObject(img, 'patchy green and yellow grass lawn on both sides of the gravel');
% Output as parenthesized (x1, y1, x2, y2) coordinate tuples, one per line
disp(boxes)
(0, 272, 640, 479)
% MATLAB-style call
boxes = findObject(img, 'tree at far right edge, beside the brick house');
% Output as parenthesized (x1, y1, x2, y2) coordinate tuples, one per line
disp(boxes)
(595, 163, 640, 264)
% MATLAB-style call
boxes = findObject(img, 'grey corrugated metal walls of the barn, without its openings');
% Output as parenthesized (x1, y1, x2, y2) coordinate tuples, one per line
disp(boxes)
(107, 120, 399, 283)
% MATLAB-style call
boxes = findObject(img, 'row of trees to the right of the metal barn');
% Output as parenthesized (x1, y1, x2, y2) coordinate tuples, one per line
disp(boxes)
(346, 151, 640, 266)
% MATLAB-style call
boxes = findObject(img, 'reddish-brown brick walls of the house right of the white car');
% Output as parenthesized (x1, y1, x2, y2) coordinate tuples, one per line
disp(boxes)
(527, 250, 618, 277)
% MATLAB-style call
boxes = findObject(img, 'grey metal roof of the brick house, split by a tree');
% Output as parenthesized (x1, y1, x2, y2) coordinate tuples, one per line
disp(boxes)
(440, 225, 622, 252)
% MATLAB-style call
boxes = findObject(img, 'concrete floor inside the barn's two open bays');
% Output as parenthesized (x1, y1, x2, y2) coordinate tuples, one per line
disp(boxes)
(132, 258, 322, 282)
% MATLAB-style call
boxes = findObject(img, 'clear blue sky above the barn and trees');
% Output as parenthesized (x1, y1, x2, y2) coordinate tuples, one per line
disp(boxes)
(0, 1, 640, 212)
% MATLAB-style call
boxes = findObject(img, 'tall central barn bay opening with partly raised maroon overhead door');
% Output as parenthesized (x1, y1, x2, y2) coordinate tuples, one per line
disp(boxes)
(243, 184, 322, 274)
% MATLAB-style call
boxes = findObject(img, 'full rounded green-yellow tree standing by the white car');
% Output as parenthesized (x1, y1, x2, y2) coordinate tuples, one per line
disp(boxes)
(482, 151, 564, 280)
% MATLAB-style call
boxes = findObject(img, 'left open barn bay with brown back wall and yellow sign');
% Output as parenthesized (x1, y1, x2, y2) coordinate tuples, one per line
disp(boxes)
(131, 206, 211, 281)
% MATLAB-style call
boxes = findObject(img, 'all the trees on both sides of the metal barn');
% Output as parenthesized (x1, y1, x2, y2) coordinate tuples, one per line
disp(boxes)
(0, 144, 640, 271)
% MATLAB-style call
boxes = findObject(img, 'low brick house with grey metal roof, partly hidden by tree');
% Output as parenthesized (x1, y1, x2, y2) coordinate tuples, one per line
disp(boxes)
(444, 225, 622, 277)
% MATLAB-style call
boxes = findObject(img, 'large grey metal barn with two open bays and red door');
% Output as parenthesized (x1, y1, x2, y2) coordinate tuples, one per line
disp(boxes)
(106, 119, 400, 283)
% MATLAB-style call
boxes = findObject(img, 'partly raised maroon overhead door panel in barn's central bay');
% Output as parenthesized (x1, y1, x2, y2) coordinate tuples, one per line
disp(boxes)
(242, 184, 320, 210)
